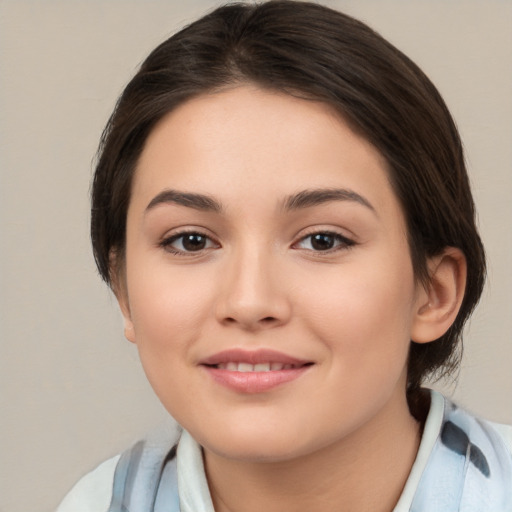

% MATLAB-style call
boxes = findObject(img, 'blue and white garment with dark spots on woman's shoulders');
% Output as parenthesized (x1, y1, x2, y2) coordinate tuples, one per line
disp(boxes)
(57, 391, 512, 512)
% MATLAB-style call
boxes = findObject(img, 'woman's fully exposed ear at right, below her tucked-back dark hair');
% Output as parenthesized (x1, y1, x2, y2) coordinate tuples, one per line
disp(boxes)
(411, 247, 467, 343)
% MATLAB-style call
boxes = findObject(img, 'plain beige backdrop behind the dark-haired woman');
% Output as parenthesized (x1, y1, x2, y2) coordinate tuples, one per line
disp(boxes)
(0, 0, 512, 512)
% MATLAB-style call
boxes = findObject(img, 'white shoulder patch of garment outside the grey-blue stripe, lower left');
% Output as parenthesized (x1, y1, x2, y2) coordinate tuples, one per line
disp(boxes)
(57, 455, 120, 512)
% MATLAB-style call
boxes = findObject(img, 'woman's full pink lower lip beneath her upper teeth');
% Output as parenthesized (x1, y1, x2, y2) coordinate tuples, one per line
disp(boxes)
(203, 366, 311, 393)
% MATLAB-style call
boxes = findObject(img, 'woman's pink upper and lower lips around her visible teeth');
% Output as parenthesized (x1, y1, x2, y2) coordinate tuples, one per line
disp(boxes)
(200, 349, 313, 394)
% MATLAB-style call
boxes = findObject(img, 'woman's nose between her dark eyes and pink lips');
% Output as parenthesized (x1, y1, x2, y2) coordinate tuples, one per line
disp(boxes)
(216, 250, 291, 331)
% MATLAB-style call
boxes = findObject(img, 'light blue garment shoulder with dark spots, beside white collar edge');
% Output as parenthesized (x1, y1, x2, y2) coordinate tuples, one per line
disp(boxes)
(406, 392, 512, 512)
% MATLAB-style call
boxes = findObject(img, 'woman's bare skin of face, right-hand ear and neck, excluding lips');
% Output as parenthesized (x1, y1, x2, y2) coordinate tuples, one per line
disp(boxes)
(117, 86, 463, 512)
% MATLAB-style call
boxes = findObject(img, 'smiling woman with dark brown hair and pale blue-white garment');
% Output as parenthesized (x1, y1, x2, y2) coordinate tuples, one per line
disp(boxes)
(59, 1, 512, 512)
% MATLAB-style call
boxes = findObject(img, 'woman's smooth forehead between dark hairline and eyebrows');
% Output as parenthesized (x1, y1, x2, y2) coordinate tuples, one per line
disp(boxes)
(132, 86, 404, 222)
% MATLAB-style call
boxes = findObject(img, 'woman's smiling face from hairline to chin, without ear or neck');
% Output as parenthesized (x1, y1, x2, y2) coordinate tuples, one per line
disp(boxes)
(120, 86, 421, 460)
